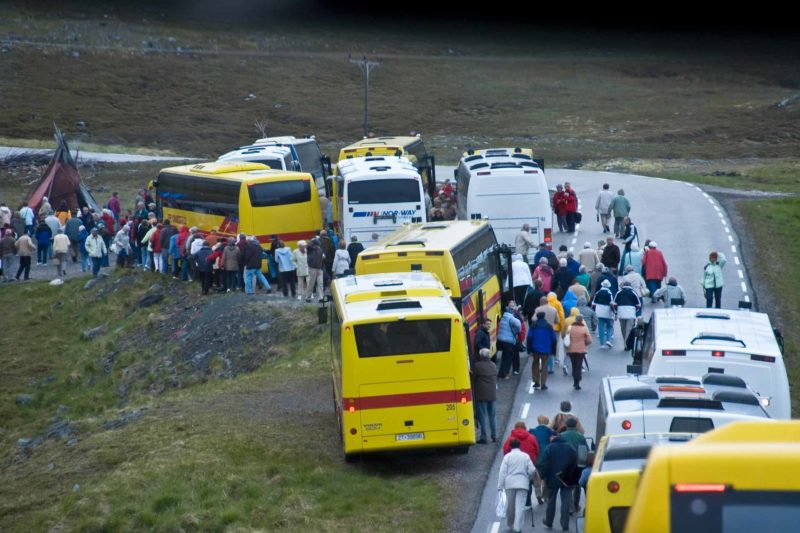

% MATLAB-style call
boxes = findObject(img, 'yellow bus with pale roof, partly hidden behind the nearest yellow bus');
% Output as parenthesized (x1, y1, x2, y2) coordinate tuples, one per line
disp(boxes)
(578, 433, 696, 533)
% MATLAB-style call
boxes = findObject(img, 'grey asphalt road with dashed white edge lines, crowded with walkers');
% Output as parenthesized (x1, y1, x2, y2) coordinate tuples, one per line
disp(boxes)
(472, 169, 751, 533)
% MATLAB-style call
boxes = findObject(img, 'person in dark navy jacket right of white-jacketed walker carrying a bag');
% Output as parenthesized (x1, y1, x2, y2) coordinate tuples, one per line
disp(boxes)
(536, 434, 578, 531)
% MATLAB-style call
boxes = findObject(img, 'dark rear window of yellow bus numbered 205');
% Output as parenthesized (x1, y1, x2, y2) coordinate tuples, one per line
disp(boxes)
(353, 318, 451, 358)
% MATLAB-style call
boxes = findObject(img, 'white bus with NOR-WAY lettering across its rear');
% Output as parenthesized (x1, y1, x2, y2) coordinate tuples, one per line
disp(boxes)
(332, 156, 427, 243)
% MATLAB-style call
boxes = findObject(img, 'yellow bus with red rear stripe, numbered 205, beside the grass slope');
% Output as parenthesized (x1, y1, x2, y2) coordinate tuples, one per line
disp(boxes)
(330, 272, 475, 459)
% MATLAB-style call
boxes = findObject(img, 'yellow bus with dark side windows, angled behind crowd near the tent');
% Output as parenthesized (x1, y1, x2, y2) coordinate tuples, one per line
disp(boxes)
(153, 162, 322, 247)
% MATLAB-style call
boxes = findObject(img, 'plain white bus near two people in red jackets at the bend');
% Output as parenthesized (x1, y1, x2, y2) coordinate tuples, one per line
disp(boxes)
(455, 148, 553, 253)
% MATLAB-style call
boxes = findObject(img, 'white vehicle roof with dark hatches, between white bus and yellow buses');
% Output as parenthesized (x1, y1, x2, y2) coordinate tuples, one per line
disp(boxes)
(596, 373, 770, 440)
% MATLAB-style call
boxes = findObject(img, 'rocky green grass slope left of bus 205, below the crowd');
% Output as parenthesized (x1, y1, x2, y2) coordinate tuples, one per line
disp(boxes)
(0, 273, 456, 531)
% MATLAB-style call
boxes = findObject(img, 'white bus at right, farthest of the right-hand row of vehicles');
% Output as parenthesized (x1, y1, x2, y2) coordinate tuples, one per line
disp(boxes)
(642, 307, 792, 419)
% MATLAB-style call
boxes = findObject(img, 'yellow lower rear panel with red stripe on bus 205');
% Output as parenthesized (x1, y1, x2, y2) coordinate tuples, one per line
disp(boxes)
(359, 379, 462, 442)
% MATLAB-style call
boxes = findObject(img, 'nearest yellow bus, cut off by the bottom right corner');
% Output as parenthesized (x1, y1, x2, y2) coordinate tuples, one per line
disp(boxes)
(625, 420, 800, 533)
